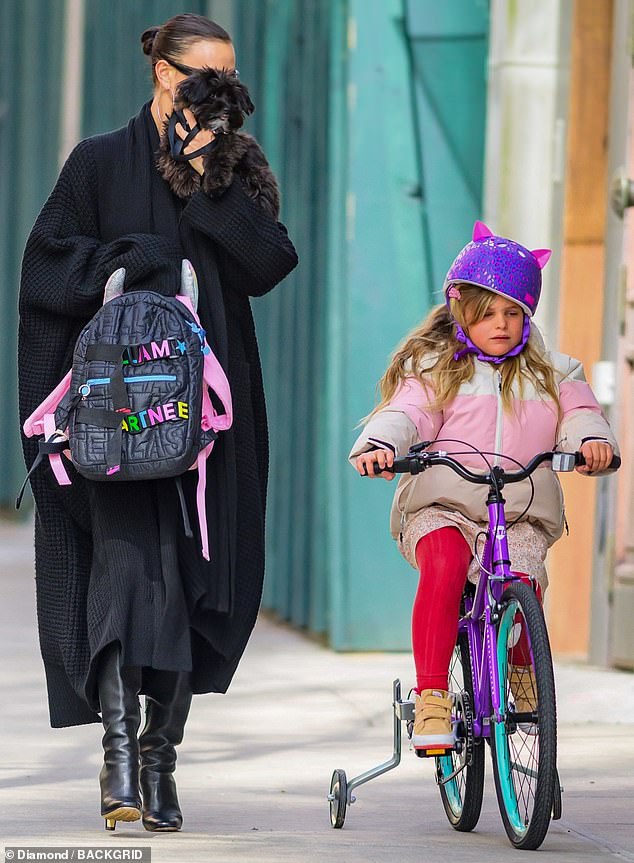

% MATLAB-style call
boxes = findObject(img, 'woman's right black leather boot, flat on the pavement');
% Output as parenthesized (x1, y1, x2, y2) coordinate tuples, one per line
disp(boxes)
(139, 671, 192, 832)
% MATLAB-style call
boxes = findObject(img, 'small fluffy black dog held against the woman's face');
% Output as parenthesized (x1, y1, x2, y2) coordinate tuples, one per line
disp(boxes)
(157, 68, 280, 219)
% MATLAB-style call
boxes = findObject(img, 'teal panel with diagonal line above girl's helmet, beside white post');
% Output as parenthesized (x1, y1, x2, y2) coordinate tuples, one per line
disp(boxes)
(405, 0, 489, 290)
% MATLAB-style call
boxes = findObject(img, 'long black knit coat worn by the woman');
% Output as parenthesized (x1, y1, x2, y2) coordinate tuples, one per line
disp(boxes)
(18, 104, 297, 727)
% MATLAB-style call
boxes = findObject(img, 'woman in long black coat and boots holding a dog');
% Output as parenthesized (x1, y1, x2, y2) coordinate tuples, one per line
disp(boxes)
(19, 15, 297, 830)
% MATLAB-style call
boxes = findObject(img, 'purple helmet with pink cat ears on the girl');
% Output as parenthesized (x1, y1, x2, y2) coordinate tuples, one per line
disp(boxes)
(443, 222, 552, 317)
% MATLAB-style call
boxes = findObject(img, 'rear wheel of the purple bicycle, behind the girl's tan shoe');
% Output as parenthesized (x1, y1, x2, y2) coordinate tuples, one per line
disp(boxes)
(436, 633, 484, 833)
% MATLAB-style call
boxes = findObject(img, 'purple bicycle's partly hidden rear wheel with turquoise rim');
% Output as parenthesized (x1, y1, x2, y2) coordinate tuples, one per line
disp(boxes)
(436, 633, 484, 832)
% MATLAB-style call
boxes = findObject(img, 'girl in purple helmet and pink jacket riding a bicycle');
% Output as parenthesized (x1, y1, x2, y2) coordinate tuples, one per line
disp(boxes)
(349, 222, 617, 752)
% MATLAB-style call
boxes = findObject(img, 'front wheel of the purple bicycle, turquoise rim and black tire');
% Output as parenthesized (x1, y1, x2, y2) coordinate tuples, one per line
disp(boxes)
(491, 582, 557, 850)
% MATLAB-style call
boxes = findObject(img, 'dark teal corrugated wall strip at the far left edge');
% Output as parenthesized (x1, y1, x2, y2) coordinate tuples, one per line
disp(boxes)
(0, 0, 64, 513)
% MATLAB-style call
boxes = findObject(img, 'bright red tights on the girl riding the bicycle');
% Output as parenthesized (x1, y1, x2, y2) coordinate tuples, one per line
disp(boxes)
(412, 527, 541, 692)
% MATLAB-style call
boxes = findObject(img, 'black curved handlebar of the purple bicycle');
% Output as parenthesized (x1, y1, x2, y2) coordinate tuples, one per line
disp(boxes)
(373, 450, 621, 485)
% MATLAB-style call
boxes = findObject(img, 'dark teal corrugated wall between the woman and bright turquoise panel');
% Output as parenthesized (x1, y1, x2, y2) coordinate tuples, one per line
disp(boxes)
(232, 0, 332, 632)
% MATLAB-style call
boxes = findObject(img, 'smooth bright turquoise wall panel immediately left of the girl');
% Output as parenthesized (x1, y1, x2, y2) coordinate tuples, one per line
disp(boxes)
(324, 0, 431, 649)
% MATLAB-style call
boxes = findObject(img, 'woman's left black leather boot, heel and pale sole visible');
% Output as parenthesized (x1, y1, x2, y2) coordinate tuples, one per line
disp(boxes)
(97, 642, 141, 830)
